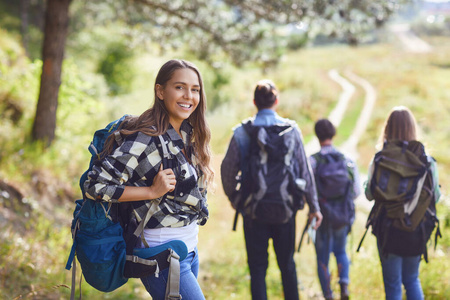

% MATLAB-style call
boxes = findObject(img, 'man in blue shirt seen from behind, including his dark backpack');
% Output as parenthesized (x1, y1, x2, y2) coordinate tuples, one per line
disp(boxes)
(221, 80, 322, 300)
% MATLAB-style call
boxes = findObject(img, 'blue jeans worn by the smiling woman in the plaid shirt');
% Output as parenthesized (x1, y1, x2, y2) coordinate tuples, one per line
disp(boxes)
(141, 249, 205, 300)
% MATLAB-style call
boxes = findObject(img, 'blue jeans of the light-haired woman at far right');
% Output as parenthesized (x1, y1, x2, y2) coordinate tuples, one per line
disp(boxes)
(380, 253, 423, 300)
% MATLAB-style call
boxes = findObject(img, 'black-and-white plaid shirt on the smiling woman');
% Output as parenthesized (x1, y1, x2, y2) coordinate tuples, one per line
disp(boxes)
(84, 121, 208, 228)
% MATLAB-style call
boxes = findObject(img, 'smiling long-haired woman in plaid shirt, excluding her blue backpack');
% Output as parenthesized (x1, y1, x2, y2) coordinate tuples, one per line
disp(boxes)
(85, 60, 213, 300)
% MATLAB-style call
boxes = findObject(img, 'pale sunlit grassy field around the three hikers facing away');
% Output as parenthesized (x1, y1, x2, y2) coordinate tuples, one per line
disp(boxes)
(199, 39, 450, 299)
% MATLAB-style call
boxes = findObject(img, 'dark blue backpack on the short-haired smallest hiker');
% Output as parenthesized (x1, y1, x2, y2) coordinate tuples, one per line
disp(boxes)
(313, 152, 355, 229)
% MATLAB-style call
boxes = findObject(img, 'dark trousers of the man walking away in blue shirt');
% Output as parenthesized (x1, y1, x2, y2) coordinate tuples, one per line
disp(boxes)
(244, 216, 299, 300)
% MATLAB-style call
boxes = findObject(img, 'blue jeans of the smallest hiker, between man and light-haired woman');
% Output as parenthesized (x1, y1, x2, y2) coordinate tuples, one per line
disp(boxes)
(315, 224, 350, 298)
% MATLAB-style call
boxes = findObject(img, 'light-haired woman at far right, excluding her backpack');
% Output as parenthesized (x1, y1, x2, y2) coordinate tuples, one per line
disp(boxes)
(365, 106, 440, 300)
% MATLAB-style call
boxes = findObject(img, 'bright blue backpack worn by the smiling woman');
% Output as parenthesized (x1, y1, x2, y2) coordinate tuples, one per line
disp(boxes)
(66, 115, 187, 299)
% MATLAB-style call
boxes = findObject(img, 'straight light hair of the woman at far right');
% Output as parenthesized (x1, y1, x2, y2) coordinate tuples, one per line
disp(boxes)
(382, 106, 418, 142)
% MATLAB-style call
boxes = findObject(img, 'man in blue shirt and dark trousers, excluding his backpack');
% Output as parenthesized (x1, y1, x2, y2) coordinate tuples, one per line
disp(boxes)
(221, 80, 322, 300)
